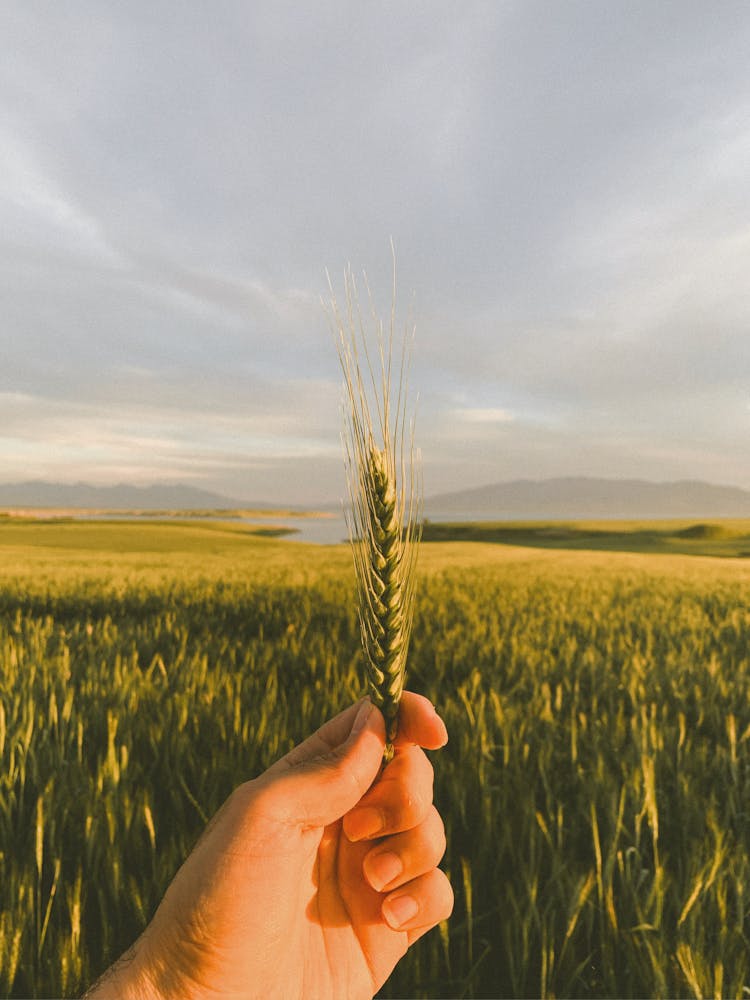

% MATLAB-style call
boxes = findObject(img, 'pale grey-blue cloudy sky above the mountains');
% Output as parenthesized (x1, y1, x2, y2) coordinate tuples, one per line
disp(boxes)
(0, 0, 750, 504)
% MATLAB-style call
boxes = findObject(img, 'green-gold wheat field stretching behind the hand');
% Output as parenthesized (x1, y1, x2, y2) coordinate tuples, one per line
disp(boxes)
(0, 519, 750, 997)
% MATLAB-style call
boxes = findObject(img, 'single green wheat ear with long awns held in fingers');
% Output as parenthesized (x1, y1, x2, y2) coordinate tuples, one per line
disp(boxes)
(328, 258, 421, 761)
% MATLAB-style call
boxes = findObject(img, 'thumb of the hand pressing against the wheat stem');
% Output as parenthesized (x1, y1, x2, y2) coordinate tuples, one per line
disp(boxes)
(266, 700, 385, 829)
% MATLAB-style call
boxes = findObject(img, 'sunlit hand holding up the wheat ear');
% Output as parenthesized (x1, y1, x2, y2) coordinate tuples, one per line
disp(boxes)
(89, 692, 453, 1000)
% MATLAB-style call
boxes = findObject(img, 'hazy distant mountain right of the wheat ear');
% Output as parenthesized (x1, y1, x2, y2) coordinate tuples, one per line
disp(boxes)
(425, 477, 750, 521)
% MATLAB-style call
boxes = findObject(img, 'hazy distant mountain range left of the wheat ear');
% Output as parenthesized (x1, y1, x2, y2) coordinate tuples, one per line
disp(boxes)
(0, 481, 253, 510)
